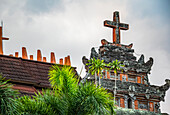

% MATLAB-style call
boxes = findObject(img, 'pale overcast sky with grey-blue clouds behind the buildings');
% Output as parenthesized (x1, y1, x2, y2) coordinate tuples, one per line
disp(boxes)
(0, 0, 170, 113)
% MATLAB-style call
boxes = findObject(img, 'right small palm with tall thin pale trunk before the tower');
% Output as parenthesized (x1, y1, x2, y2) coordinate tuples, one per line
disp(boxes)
(108, 59, 124, 102)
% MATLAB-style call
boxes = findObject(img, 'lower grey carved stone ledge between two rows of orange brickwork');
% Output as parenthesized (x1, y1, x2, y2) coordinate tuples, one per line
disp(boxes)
(101, 79, 170, 101)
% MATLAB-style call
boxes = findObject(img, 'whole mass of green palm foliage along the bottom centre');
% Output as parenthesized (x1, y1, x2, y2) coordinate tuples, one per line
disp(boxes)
(16, 65, 114, 115)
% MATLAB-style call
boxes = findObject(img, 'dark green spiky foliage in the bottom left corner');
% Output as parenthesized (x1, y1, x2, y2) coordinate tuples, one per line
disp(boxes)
(0, 75, 18, 115)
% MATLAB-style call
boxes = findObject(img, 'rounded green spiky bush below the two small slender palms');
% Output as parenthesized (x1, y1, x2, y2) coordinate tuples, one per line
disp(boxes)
(78, 83, 114, 115)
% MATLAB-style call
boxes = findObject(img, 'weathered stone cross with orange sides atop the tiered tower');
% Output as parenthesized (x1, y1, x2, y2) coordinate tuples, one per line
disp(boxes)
(104, 11, 129, 44)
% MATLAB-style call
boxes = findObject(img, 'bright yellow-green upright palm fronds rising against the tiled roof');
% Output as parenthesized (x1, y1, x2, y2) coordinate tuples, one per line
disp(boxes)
(49, 65, 78, 95)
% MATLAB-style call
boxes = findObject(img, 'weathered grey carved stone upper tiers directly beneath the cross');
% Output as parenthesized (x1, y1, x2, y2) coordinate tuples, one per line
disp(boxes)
(82, 41, 153, 74)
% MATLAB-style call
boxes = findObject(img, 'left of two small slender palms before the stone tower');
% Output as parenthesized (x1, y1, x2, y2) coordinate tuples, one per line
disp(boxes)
(87, 58, 106, 86)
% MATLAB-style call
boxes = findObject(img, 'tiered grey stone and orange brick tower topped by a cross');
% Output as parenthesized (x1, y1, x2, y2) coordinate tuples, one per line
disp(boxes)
(82, 11, 170, 113)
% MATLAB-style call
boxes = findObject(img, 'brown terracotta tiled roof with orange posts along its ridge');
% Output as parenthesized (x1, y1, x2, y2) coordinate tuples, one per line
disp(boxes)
(0, 55, 77, 93)
